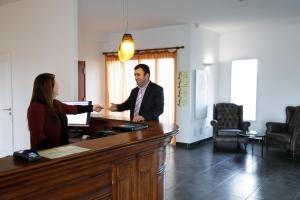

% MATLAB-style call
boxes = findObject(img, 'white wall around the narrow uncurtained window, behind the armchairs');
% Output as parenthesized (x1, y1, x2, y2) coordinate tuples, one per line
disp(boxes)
(218, 25, 300, 132)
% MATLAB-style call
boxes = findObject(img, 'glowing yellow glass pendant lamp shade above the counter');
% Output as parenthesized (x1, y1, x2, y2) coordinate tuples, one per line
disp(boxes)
(118, 33, 134, 61)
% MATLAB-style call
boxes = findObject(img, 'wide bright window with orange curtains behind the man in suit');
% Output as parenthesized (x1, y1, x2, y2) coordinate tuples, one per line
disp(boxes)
(105, 52, 177, 123)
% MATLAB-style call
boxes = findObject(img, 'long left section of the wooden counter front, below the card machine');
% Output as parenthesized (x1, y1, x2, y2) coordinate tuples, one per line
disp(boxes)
(0, 156, 112, 200)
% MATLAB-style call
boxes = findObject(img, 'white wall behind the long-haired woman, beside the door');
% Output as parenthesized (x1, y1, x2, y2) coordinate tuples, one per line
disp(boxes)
(0, 0, 77, 150)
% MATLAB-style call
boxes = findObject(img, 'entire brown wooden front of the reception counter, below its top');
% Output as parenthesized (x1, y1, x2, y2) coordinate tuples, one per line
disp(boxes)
(0, 139, 169, 200)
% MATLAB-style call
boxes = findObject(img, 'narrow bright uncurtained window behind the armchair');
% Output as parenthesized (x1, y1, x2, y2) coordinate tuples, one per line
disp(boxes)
(231, 59, 257, 121)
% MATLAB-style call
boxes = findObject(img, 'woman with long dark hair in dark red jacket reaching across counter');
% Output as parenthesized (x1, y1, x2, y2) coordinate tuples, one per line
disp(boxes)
(27, 73, 103, 150)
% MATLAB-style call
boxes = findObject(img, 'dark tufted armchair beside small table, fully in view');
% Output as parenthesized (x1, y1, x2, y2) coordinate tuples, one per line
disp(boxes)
(211, 103, 250, 147)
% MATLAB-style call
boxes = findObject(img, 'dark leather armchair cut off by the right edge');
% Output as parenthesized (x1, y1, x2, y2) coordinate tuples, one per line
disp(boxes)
(266, 106, 300, 158)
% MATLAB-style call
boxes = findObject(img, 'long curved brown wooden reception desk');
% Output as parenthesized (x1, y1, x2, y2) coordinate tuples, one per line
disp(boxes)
(0, 117, 178, 200)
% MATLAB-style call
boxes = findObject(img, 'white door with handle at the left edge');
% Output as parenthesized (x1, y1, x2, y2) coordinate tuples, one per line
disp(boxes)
(0, 52, 13, 157)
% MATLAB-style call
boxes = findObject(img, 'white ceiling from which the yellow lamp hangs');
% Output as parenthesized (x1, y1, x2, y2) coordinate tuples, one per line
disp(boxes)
(78, 0, 300, 33)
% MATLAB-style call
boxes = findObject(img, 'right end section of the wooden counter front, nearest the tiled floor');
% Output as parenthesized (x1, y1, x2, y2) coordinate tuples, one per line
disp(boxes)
(113, 147, 165, 200)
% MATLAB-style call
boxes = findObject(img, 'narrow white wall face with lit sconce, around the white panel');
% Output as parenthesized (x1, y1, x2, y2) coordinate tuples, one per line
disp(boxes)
(186, 27, 219, 143)
